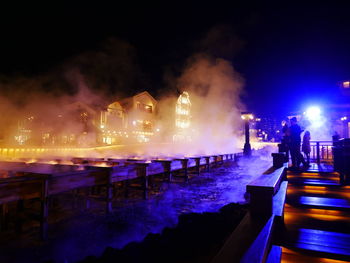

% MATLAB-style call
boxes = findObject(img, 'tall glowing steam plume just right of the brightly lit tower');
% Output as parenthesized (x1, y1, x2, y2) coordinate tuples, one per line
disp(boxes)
(172, 54, 243, 154)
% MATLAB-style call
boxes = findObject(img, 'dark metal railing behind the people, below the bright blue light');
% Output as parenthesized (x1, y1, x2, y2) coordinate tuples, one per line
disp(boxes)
(310, 141, 333, 163)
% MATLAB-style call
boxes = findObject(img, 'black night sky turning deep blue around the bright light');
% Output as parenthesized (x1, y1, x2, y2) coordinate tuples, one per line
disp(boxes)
(0, 1, 350, 116)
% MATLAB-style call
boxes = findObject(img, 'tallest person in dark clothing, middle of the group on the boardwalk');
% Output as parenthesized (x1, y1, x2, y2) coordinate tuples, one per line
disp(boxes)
(289, 117, 307, 169)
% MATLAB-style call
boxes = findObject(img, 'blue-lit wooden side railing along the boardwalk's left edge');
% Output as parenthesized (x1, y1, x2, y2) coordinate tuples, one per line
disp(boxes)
(212, 159, 287, 263)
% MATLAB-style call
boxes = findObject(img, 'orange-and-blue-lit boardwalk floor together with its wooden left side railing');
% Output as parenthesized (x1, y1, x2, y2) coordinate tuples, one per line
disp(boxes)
(212, 159, 350, 263)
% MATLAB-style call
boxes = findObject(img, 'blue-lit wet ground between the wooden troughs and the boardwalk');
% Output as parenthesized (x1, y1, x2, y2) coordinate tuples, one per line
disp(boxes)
(0, 159, 271, 263)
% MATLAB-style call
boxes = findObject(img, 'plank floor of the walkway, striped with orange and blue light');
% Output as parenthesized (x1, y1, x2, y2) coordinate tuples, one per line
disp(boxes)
(280, 164, 350, 262)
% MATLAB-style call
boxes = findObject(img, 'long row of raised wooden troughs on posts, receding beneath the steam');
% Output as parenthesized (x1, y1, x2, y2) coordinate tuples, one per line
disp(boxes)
(0, 154, 235, 239)
